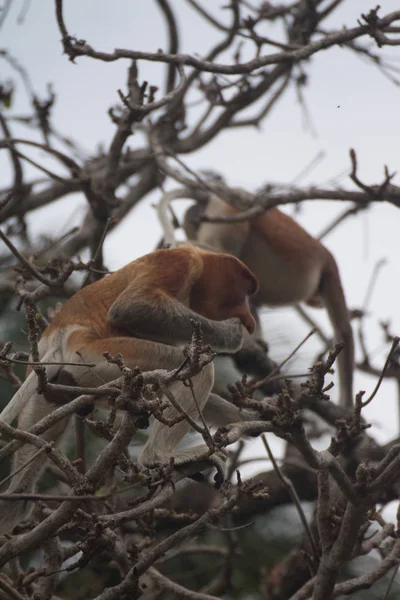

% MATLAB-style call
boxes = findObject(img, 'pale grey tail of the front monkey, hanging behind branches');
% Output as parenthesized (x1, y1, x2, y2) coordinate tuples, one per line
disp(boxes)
(0, 348, 64, 534)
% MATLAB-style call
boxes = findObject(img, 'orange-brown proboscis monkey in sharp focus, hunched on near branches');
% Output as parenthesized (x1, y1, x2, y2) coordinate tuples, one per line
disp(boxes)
(0, 246, 258, 532)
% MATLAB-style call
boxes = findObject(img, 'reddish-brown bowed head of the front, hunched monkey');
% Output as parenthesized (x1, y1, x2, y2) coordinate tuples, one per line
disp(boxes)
(190, 252, 258, 333)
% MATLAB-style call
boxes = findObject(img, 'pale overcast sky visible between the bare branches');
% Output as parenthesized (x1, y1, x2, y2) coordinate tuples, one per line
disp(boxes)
(0, 0, 400, 478)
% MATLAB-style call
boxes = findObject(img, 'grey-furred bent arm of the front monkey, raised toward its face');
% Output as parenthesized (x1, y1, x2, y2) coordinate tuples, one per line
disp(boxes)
(108, 286, 243, 352)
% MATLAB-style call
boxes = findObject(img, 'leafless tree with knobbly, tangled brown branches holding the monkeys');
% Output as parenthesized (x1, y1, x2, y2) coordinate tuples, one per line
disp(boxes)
(0, 0, 400, 600)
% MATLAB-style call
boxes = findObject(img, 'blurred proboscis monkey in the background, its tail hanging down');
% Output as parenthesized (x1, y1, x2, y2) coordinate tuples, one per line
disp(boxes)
(184, 195, 354, 408)
